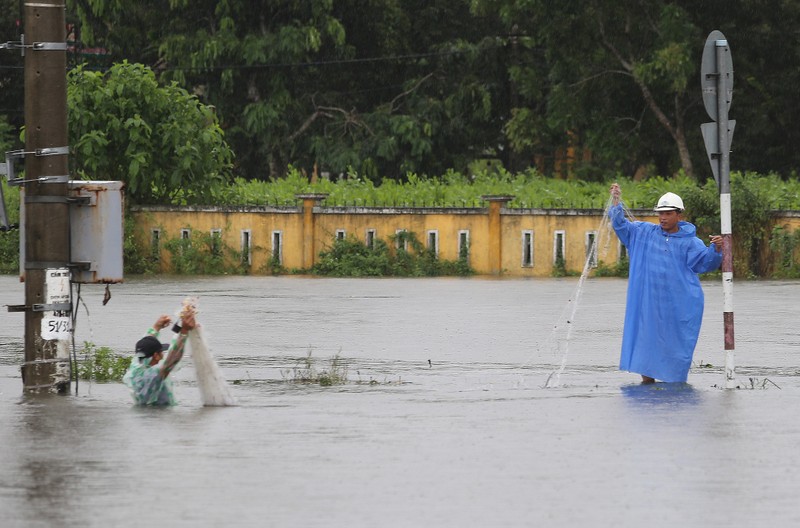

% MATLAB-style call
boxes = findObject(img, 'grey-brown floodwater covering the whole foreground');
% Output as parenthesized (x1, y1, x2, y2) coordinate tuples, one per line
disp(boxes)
(0, 277, 800, 527)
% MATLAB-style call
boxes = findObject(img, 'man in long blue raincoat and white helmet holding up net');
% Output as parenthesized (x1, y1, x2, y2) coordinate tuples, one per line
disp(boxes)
(608, 183, 722, 383)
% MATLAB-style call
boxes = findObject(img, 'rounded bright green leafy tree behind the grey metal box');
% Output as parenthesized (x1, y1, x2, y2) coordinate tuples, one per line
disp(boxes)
(67, 62, 233, 203)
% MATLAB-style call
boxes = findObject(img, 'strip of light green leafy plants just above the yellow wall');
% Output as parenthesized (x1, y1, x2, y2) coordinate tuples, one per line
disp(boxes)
(214, 169, 800, 212)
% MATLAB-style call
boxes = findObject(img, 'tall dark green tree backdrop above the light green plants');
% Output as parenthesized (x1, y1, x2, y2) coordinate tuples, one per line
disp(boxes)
(15, 0, 800, 184)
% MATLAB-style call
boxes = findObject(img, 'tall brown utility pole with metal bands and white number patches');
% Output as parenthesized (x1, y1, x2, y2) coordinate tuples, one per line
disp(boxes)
(16, 0, 72, 392)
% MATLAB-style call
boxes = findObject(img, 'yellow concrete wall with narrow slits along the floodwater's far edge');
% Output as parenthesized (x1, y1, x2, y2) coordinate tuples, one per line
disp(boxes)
(133, 205, 800, 277)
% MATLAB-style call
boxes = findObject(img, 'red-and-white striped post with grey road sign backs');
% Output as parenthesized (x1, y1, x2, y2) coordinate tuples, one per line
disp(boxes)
(700, 30, 736, 389)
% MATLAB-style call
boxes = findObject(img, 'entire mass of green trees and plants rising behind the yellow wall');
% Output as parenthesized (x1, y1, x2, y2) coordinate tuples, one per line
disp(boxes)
(0, 0, 800, 273)
